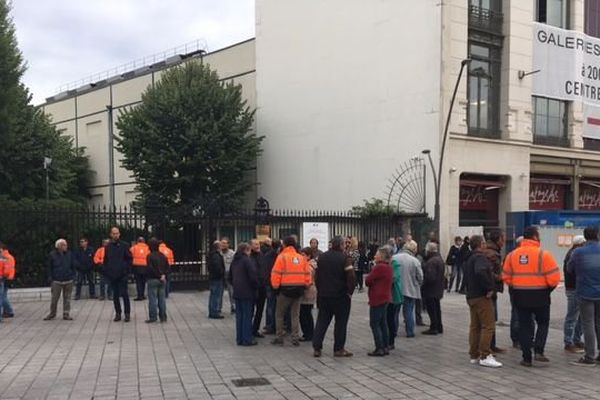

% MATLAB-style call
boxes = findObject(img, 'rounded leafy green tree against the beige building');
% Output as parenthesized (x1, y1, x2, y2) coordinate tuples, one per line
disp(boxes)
(117, 61, 263, 219)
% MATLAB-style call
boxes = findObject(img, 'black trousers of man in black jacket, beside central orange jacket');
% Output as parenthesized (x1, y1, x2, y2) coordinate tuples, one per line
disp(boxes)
(313, 295, 351, 351)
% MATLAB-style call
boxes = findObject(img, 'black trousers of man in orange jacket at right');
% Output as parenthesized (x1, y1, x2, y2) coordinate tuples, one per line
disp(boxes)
(517, 305, 550, 362)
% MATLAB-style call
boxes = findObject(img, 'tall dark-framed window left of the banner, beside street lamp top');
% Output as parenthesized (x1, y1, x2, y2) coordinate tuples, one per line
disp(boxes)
(467, 43, 500, 136)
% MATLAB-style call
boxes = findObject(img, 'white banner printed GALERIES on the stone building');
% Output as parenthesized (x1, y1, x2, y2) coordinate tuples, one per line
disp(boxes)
(532, 23, 600, 138)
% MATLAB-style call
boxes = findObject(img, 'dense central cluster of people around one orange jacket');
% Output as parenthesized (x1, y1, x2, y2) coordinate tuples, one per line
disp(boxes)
(207, 231, 446, 357)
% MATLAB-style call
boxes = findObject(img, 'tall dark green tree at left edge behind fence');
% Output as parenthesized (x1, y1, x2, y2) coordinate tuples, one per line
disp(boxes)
(0, 0, 90, 202)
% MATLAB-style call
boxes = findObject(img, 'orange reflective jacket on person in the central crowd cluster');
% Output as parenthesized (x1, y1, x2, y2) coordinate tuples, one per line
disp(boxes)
(271, 246, 312, 289)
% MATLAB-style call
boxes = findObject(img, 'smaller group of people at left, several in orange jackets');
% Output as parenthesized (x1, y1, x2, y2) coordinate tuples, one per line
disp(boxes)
(5, 227, 175, 323)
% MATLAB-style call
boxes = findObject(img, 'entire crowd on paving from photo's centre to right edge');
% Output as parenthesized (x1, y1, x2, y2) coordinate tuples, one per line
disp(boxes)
(203, 223, 600, 368)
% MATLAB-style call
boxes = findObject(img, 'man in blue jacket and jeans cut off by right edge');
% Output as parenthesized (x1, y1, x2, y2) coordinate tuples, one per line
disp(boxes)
(567, 226, 600, 367)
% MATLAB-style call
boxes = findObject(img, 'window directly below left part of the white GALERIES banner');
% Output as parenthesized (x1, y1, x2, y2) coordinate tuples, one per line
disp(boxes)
(532, 96, 569, 146)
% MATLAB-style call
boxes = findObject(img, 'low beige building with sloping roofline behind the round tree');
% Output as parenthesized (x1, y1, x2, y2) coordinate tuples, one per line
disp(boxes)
(42, 39, 256, 207)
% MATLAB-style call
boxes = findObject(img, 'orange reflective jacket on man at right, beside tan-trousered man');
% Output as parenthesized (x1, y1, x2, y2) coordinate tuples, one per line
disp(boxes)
(502, 239, 560, 290)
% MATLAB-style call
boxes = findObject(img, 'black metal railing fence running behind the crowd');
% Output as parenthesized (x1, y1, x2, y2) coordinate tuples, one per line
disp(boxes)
(0, 208, 428, 290)
